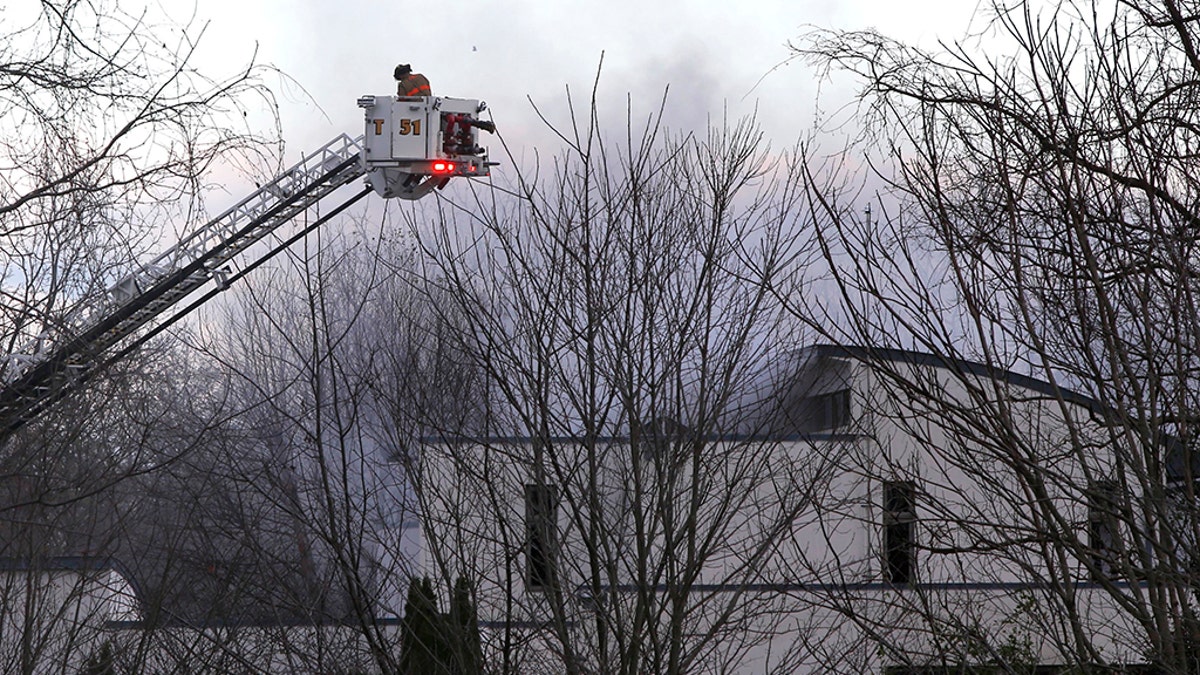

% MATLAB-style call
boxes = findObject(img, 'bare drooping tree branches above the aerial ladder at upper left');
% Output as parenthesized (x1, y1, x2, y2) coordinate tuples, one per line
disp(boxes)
(0, 0, 269, 377)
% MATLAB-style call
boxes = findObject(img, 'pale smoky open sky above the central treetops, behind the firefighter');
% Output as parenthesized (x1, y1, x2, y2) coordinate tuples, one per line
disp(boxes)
(194, 0, 974, 170)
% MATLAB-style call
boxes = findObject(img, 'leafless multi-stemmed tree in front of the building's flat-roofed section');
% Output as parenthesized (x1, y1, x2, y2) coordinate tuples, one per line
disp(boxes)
(381, 86, 821, 673)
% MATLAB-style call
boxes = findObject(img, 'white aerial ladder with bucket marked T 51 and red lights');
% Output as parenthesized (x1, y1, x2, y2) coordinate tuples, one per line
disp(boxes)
(0, 96, 494, 444)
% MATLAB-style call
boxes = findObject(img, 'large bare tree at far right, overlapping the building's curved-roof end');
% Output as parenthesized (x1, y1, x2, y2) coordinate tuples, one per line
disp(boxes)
(793, 0, 1200, 673)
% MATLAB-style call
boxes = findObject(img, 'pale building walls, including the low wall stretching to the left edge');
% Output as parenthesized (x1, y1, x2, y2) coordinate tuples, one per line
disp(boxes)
(0, 359, 1145, 674)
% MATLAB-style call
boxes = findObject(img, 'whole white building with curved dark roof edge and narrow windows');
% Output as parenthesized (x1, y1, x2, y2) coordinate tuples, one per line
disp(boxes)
(419, 346, 1171, 674)
